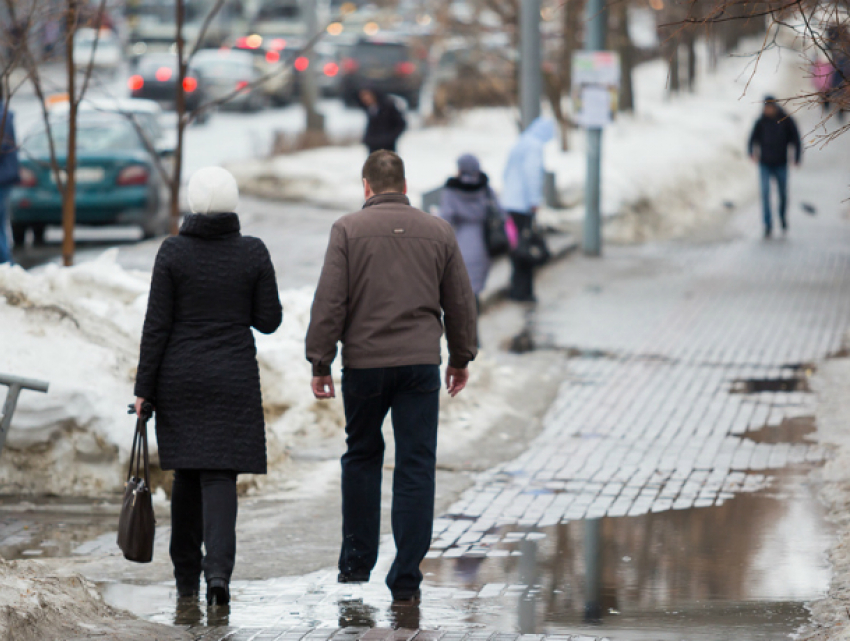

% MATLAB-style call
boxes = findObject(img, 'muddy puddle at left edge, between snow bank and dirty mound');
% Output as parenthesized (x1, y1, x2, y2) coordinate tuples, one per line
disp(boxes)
(0, 496, 118, 560)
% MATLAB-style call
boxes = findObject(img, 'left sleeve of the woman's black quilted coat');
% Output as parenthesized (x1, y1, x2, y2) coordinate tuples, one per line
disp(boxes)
(135, 240, 175, 399)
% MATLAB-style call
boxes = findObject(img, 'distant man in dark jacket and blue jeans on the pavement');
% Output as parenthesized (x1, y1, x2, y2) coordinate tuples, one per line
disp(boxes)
(748, 96, 803, 238)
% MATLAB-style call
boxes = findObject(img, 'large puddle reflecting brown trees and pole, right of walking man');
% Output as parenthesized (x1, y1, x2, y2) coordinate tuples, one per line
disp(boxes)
(424, 468, 829, 640)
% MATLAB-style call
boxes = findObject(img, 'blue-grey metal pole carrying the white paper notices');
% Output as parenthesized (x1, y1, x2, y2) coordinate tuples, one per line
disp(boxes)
(583, 0, 608, 256)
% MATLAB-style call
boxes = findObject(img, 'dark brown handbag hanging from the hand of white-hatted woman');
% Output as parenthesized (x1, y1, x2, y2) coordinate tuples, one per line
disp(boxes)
(118, 403, 156, 563)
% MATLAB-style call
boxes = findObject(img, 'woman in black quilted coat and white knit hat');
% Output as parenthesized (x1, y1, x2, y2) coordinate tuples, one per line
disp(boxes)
(135, 167, 283, 605)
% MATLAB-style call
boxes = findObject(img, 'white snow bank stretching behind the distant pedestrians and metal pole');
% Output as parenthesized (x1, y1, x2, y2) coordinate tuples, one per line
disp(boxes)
(230, 37, 804, 241)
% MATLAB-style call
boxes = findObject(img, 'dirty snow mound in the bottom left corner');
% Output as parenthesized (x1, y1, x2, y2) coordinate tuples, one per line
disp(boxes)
(0, 559, 192, 641)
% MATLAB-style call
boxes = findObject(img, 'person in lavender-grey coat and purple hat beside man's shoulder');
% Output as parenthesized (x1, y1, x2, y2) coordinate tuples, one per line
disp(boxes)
(440, 154, 499, 312)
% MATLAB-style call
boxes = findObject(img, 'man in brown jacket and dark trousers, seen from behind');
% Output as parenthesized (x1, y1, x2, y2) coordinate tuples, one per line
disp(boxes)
(307, 151, 478, 601)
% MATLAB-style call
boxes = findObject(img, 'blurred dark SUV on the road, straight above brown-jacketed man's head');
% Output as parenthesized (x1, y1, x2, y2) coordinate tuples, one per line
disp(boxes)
(342, 40, 423, 109)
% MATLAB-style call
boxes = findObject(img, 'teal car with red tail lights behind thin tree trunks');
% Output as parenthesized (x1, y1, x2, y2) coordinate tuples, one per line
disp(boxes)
(10, 111, 169, 245)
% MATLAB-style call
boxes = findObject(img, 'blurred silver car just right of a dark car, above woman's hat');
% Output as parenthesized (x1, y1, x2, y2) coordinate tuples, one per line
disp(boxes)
(192, 49, 270, 111)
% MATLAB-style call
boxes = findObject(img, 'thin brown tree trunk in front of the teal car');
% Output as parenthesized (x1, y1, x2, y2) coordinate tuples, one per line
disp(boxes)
(62, 0, 79, 267)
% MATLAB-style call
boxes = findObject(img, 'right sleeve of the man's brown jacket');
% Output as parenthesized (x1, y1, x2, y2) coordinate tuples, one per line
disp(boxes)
(440, 236, 478, 369)
